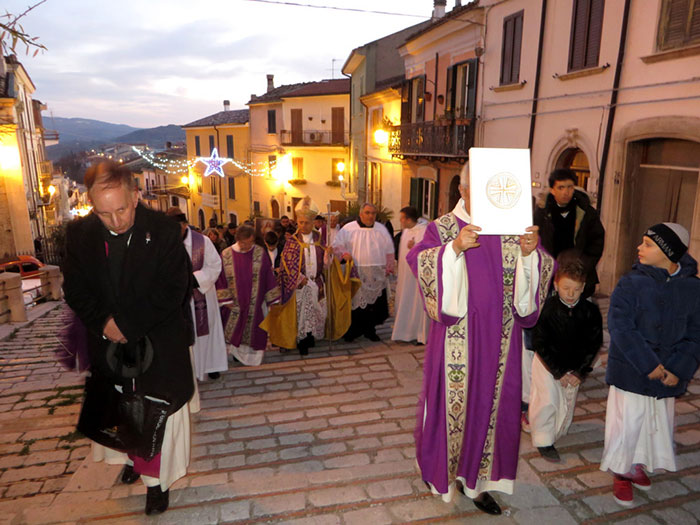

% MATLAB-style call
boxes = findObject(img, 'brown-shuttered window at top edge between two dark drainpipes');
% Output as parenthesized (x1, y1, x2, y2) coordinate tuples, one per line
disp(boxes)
(569, 0, 605, 71)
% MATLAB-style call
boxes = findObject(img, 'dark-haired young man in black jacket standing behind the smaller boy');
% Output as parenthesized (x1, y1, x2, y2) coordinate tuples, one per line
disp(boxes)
(534, 168, 605, 299)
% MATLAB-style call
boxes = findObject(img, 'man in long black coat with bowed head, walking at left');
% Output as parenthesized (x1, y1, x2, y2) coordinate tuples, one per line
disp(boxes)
(62, 162, 194, 514)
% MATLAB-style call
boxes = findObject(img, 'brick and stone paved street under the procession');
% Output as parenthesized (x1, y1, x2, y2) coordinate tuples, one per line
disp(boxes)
(0, 298, 700, 525)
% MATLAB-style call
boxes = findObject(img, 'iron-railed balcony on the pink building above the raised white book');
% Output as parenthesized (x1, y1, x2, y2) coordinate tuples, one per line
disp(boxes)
(389, 119, 475, 157)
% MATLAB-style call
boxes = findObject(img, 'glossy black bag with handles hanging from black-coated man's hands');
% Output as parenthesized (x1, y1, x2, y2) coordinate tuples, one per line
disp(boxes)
(78, 337, 171, 461)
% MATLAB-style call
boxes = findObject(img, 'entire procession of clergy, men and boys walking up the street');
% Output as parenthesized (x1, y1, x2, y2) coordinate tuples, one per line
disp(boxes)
(62, 157, 700, 514)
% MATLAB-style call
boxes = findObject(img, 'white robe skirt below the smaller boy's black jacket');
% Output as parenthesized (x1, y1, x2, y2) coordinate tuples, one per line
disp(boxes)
(529, 355, 579, 447)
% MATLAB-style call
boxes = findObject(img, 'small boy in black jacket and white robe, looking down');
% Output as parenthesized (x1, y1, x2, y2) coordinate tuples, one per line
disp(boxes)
(529, 253, 603, 462)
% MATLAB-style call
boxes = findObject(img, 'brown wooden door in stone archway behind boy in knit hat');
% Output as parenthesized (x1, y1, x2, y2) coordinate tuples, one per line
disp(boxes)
(623, 138, 700, 269)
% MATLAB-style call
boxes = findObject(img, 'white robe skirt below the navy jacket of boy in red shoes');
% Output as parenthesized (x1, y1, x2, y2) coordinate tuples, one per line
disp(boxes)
(600, 386, 676, 475)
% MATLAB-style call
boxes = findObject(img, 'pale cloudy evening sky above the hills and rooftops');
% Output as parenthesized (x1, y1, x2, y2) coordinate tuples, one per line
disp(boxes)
(3, 0, 438, 127)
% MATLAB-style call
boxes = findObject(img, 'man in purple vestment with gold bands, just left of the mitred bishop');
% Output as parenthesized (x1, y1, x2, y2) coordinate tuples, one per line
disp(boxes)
(216, 225, 280, 366)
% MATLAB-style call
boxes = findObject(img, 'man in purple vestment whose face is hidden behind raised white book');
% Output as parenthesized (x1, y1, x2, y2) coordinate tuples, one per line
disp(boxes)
(407, 165, 554, 514)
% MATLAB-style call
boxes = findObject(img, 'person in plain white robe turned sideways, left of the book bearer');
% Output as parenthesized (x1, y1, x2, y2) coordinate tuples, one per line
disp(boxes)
(391, 206, 430, 343)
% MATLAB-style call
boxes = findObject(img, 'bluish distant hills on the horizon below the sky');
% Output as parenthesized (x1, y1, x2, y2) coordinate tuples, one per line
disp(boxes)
(44, 117, 185, 161)
